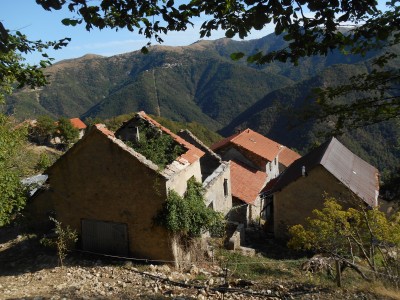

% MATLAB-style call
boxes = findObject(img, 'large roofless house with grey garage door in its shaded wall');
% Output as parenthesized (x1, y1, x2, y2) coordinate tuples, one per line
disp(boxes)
(29, 113, 230, 261)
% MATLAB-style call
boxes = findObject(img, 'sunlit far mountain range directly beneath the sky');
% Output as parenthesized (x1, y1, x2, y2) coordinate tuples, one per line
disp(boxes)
(7, 35, 378, 129)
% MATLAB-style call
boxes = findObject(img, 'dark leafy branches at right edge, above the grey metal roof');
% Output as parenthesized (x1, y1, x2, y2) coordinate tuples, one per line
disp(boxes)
(306, 54, 400, 134)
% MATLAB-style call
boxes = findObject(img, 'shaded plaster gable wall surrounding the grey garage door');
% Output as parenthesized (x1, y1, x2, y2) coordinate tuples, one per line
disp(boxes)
(31, 132, 173, 260)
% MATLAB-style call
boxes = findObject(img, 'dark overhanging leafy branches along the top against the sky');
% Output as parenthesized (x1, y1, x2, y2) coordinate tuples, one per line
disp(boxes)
(37, 0, 399, 63)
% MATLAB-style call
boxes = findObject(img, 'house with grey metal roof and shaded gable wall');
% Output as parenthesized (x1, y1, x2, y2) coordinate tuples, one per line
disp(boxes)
(262, 138, 379, 239)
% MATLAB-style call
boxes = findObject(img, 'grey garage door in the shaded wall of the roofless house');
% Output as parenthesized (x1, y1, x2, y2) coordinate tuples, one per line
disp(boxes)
(82, 219, 129, 255)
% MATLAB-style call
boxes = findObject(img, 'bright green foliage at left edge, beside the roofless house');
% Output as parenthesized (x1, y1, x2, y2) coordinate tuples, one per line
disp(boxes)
(0, 114, 26, 227)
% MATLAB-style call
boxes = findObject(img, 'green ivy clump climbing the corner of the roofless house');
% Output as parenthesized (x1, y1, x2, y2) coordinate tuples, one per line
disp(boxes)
(155, 177, 224, 238)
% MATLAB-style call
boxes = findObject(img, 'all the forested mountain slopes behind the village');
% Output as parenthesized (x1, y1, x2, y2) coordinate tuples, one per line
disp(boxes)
(6, 35, 400, 178)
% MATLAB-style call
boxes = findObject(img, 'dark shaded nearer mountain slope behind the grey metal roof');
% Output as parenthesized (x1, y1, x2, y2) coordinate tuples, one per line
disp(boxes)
(219, 61, 400, 173)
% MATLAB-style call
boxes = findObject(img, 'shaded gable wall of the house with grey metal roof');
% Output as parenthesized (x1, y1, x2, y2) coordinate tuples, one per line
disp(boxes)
(273, 166, 351, 239)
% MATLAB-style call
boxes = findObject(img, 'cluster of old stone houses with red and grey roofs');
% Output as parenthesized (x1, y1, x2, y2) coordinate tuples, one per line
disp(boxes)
(0, 112, 396, 299)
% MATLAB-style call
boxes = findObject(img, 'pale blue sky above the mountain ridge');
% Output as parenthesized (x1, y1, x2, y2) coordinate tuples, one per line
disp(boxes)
(0, 0, 385, 63)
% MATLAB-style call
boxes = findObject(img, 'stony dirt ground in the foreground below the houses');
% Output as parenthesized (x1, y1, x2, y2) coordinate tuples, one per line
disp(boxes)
(0, 228, 395, 300)
